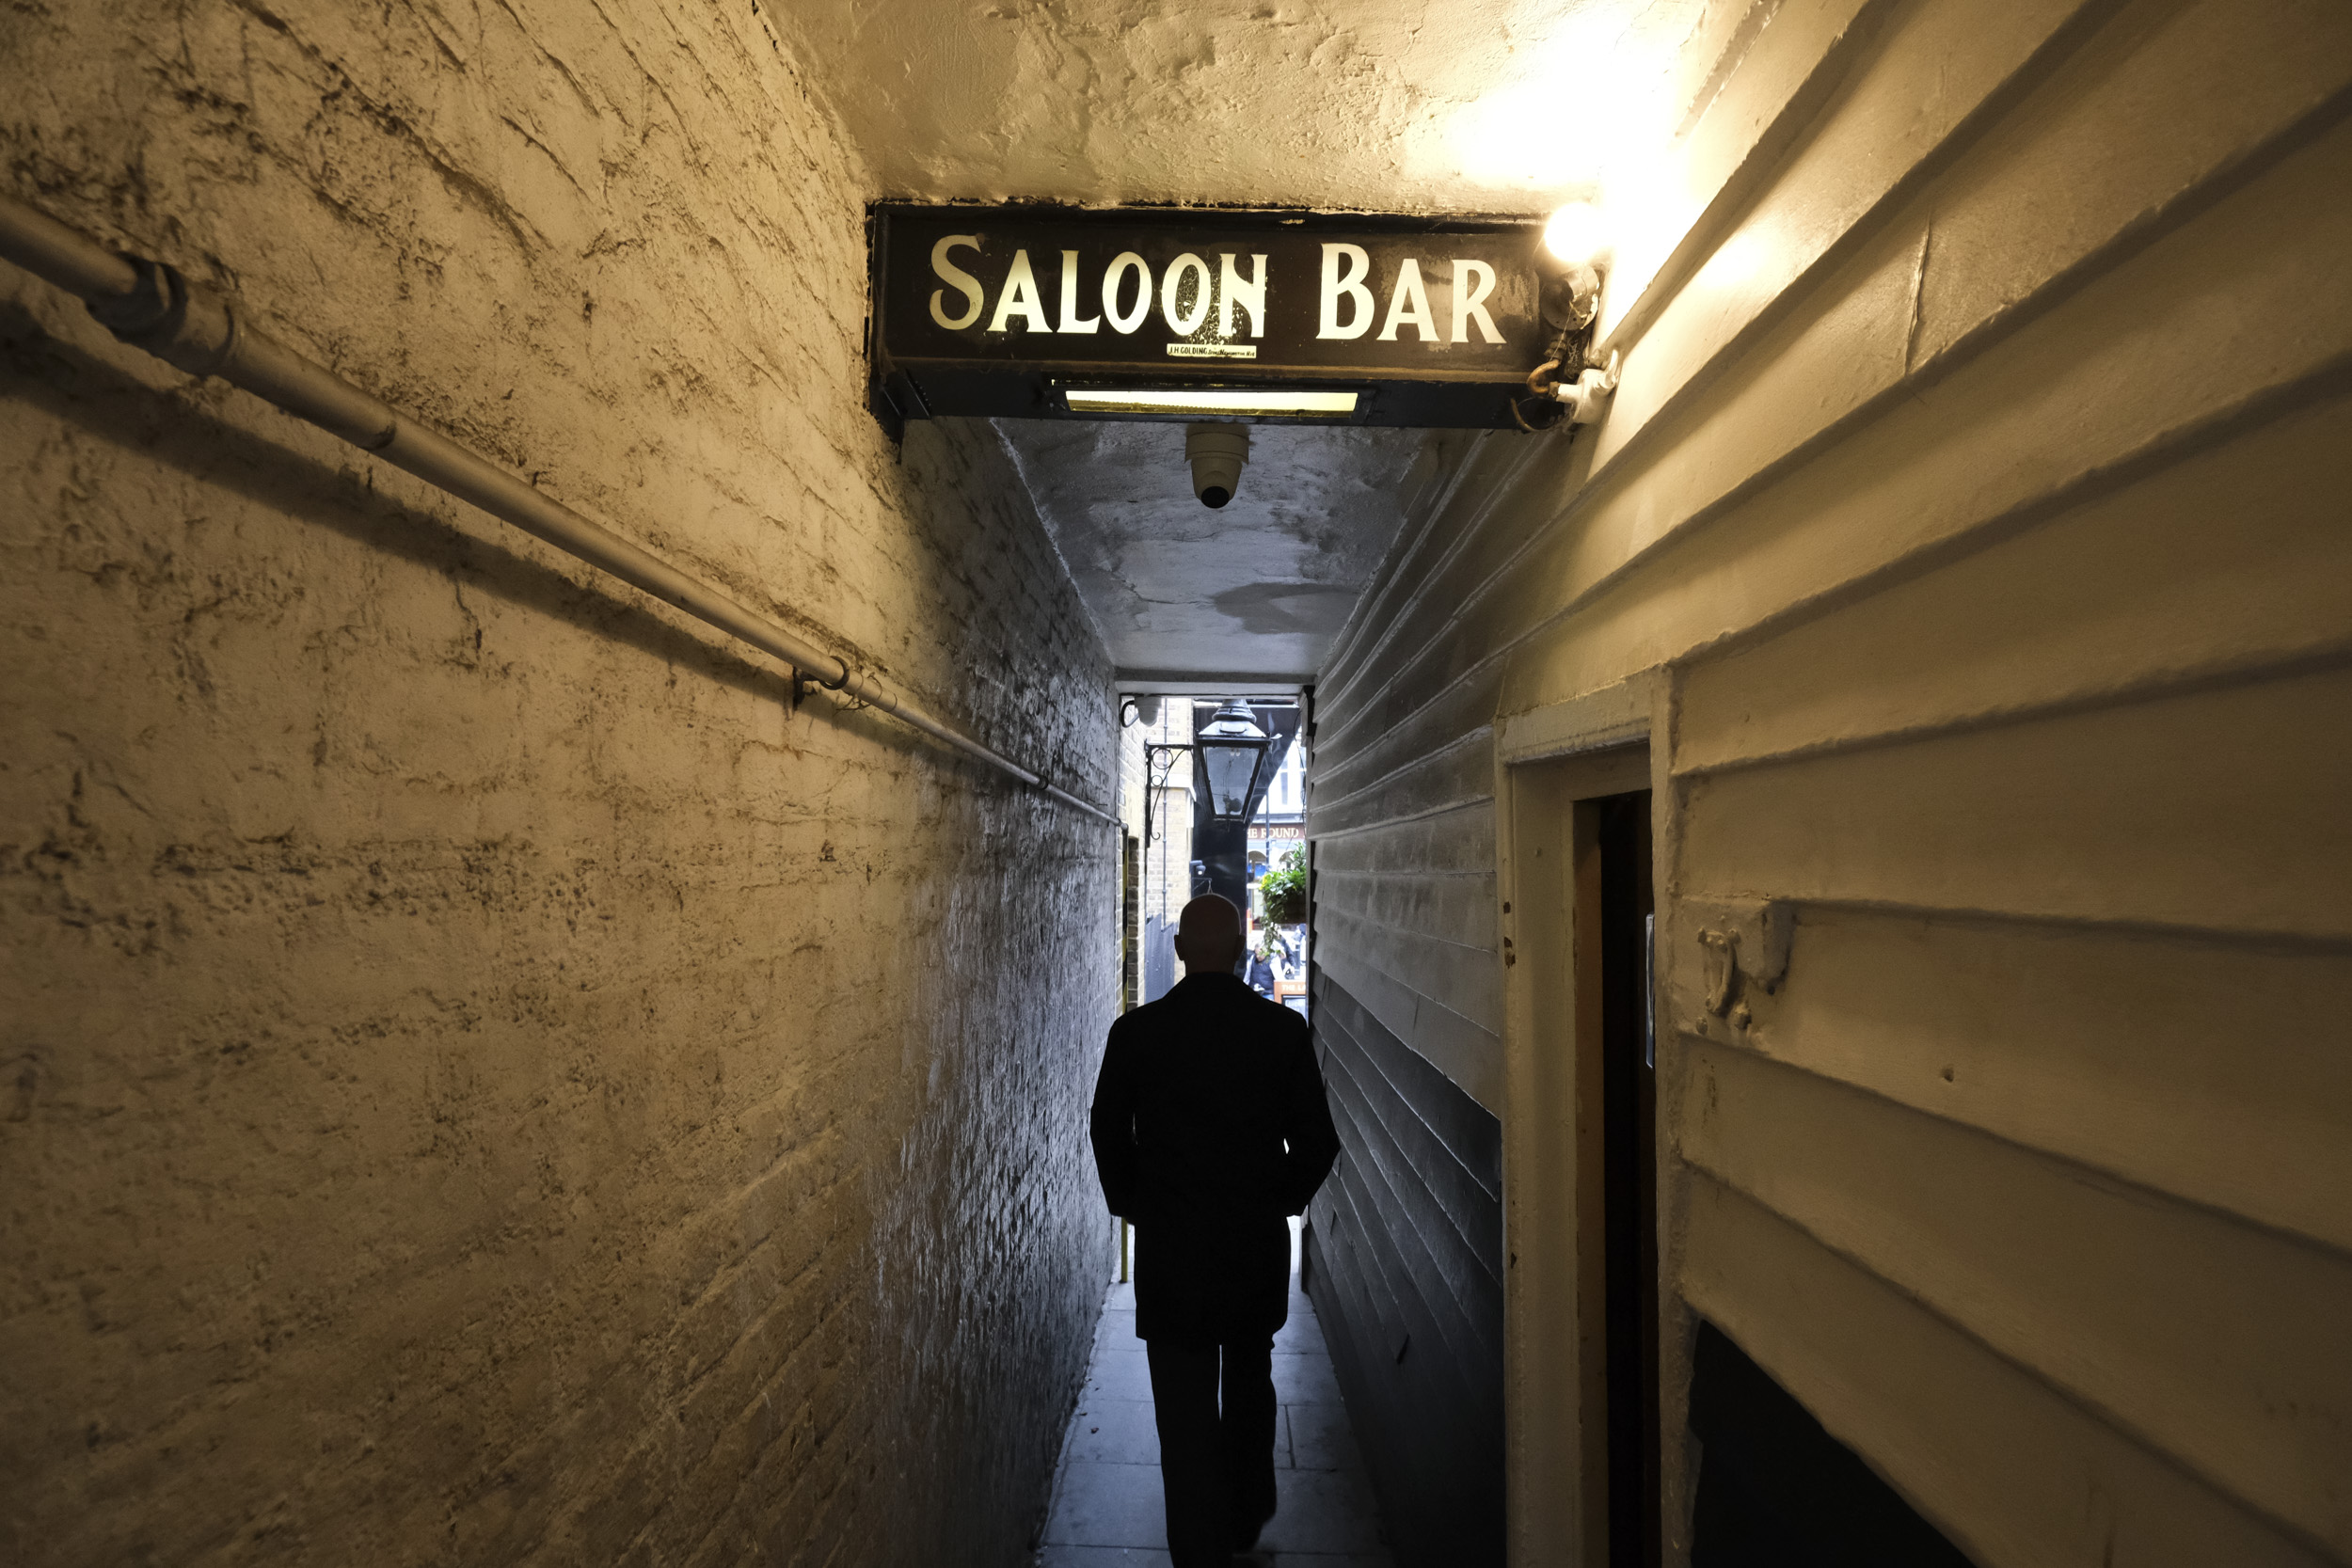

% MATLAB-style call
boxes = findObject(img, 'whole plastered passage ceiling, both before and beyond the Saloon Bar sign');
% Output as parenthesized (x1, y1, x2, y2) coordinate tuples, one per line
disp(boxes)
(779, 0, 1722, 689)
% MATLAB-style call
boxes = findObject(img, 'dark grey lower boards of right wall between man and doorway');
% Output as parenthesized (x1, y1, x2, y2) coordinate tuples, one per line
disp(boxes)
(1306, 975, 1503, 1568)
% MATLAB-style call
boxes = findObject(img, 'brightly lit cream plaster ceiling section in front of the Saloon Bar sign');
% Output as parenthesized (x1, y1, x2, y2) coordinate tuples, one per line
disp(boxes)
(762, 0, 1703, 212)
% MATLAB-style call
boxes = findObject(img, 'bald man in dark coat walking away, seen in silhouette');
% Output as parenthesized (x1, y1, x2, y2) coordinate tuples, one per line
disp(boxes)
(1094, 894, 1339, 1568)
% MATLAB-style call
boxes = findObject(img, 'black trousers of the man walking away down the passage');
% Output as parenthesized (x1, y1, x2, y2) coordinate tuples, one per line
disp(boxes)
(1143, 1338, 1275, 1568)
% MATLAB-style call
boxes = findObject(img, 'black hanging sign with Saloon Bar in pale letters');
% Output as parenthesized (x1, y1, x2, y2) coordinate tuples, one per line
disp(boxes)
(873, 207, 1548, 428)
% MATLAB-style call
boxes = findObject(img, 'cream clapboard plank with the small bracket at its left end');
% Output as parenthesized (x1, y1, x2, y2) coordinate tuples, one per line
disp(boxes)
(1712, 905, 2352, 1253)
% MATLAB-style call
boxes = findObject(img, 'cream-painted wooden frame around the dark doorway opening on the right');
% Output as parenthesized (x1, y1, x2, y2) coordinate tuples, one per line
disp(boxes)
(1494, 670, 1687, 1568)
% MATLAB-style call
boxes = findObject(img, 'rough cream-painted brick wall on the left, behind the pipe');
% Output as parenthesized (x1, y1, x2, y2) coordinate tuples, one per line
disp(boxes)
(0, 0, 1115, 1563)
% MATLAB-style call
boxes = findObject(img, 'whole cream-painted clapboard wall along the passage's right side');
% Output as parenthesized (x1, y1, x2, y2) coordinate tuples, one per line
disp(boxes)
(1311, 0, 2352, 1566)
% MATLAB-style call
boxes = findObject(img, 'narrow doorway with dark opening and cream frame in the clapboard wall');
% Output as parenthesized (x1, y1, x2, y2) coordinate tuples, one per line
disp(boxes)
(1496, 705, 1679, 1568)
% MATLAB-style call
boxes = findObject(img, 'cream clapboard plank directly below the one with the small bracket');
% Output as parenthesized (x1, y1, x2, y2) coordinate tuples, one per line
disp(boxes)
(1679, 1046, 2352, 1554)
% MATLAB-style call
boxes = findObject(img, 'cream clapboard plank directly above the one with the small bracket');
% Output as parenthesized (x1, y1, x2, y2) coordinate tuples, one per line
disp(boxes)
(1684, 668, 2352, 941)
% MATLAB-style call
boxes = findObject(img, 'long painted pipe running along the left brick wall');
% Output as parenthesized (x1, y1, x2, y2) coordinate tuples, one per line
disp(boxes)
(0, 195, 1120, 823)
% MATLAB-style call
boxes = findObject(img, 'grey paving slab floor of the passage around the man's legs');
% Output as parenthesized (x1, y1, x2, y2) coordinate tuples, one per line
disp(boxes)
(1038, 1223, 1391, 1568)
